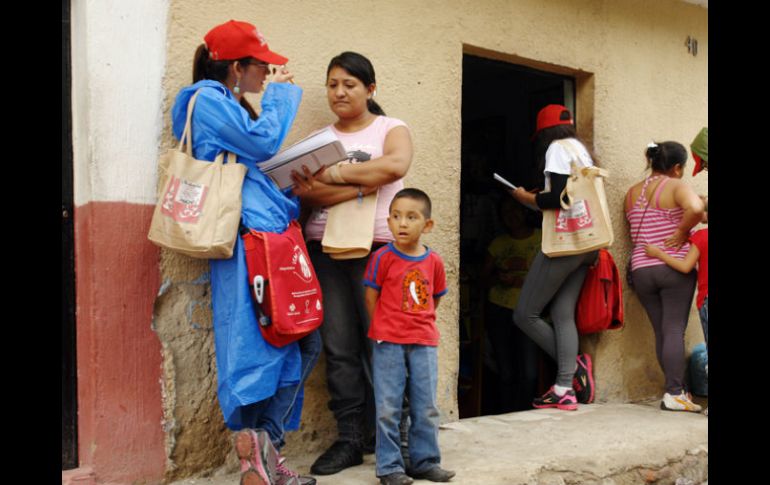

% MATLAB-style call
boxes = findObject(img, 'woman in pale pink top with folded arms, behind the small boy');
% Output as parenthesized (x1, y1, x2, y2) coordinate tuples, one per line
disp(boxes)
(299, 52, 412, 475)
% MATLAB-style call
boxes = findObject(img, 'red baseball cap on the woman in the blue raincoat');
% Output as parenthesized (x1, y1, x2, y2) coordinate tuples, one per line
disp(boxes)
(203, 20, 289, 65)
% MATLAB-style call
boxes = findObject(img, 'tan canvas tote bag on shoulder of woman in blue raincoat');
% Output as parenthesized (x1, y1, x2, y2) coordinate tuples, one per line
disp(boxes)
(147, 90, 248, 259)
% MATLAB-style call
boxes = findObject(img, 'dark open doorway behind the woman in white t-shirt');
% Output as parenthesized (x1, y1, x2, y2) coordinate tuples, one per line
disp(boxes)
(458, 54, 578, 418)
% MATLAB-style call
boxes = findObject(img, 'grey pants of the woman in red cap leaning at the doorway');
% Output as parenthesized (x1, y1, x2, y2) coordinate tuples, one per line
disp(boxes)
(513, 251, 599, 387)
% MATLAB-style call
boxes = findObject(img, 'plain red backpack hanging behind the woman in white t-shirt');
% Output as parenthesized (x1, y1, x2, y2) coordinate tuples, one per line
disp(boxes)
(575, 249, 623, 335)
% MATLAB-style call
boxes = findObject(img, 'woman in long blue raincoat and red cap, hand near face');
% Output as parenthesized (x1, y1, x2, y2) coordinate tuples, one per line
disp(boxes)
(172, 20, 321, 485)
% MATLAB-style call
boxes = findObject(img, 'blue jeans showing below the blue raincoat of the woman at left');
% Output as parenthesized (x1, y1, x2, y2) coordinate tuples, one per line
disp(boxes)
(241, 330, 321, 451)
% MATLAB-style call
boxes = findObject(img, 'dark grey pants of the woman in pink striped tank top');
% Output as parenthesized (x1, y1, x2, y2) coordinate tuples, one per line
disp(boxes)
(631, 264, 698, 394)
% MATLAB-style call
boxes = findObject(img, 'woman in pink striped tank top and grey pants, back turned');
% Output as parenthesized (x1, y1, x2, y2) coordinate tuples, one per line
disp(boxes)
(625, 141, 703, 412)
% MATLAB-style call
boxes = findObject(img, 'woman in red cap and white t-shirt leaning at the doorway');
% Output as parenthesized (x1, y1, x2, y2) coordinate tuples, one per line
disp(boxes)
(511, 104, 598, 411)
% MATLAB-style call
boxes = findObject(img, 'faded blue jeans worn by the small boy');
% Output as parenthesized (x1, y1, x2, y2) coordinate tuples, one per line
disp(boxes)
(372, 342, 441, 477)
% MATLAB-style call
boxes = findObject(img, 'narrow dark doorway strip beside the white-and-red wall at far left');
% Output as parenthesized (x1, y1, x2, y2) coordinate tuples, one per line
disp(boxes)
(61, 0, 78, 470)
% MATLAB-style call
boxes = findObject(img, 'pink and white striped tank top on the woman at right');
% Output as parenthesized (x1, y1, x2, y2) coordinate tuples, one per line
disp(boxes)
(626, 175, 690, 271)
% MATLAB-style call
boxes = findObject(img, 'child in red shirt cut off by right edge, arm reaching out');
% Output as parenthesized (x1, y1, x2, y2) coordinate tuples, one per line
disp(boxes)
(644, 196, 709, 416)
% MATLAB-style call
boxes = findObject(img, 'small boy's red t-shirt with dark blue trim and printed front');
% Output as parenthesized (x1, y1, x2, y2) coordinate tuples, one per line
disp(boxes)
(364, 242, 447, 346)
